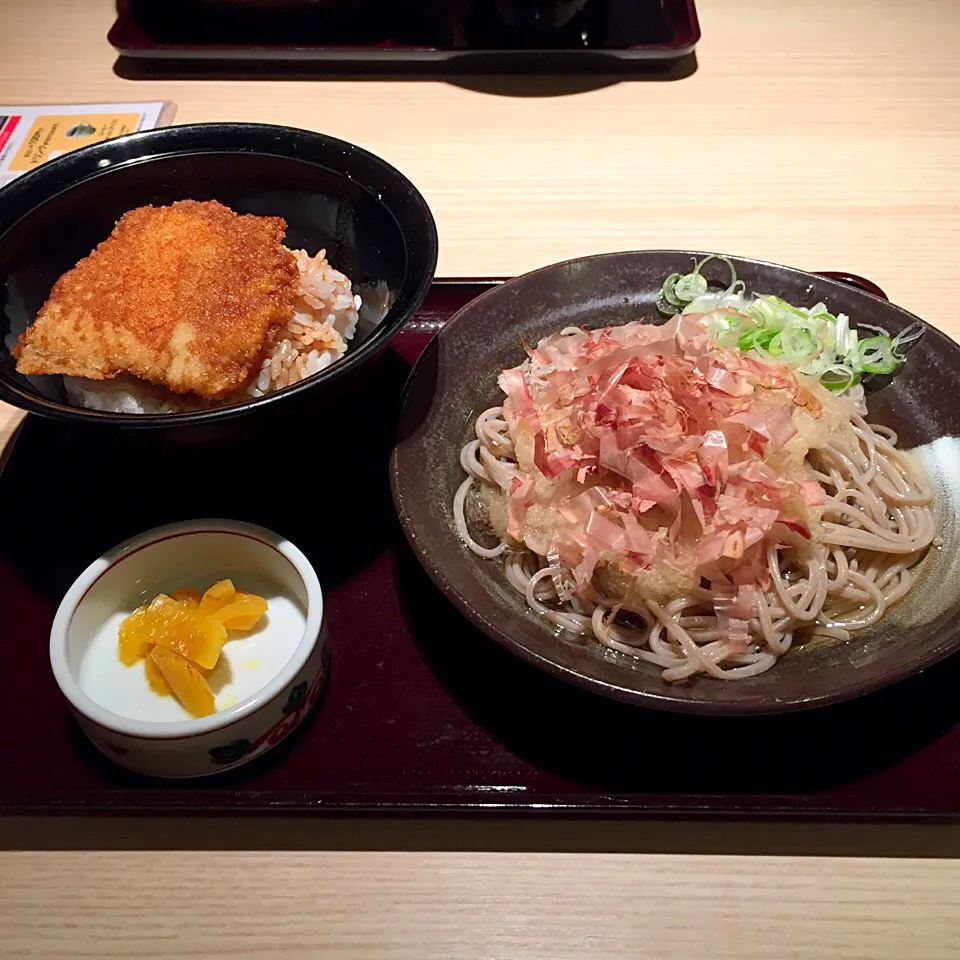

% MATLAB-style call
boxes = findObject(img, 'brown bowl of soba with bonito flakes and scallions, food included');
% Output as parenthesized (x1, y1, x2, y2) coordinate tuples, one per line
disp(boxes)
(391, 250, 960, 714)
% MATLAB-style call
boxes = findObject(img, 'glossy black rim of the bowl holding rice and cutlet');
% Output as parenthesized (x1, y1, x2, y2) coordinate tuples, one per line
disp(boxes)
(0, 121, 439, 430)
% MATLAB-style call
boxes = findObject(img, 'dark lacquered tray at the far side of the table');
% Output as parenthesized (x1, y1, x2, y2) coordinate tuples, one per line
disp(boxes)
(108, 0, 700, 72)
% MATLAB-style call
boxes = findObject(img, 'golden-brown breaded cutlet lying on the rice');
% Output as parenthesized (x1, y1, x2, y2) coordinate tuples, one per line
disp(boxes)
(13, 200, 299, 397)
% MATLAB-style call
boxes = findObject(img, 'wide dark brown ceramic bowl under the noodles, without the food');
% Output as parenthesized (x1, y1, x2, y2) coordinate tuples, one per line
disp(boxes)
(391, 250, 960, 714)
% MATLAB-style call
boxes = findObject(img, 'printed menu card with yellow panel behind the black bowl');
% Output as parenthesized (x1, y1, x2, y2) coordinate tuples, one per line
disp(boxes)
(0, 100, 176, 186)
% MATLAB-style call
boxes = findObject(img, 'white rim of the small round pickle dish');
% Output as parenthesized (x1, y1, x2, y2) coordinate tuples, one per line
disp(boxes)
(50, 518, 324, 740)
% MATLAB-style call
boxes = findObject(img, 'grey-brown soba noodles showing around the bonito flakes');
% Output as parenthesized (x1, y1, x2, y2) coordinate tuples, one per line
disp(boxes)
(453, 331, 936, 681)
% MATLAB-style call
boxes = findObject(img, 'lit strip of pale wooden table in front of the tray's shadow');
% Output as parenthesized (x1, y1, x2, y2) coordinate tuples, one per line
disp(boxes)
(0, 851, 960, 960)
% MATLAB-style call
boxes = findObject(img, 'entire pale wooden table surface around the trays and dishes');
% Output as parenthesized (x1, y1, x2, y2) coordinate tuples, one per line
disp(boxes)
(0, 0, 960, 960)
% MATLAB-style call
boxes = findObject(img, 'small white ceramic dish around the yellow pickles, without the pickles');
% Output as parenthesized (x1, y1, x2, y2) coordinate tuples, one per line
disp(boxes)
(50, 520, 326, 777)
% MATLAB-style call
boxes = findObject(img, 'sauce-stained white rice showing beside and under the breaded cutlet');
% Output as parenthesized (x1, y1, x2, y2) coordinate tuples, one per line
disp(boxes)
(63, 250, 361, 413)
